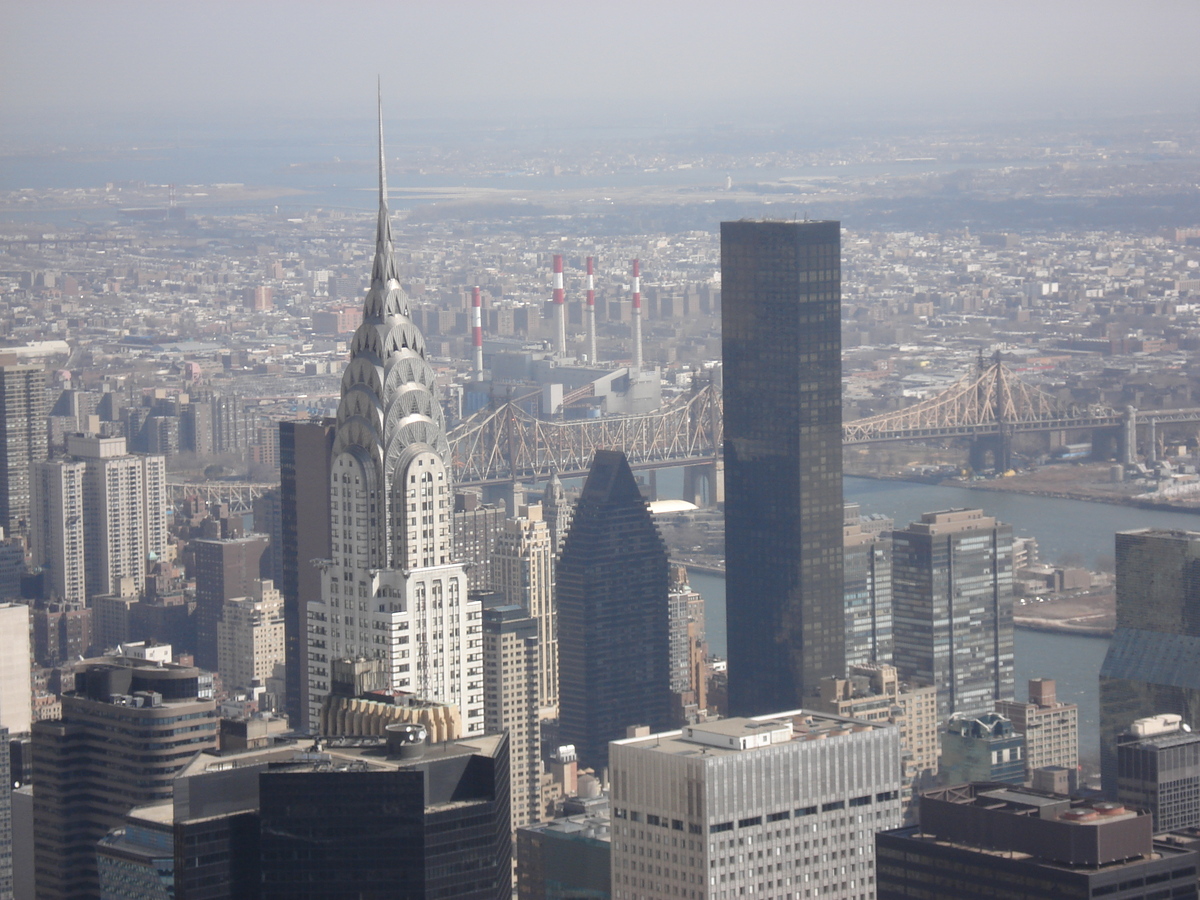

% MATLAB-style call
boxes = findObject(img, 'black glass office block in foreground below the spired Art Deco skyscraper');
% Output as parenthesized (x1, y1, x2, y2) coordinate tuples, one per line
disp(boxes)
(258, 726, 512, 900)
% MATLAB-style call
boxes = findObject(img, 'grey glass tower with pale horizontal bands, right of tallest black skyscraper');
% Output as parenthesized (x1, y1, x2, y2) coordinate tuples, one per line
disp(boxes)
(892, 509, 1014, 719)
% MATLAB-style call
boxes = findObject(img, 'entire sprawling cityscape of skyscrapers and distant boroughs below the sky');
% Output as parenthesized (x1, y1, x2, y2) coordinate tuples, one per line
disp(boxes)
(0, 112, 1200, 900)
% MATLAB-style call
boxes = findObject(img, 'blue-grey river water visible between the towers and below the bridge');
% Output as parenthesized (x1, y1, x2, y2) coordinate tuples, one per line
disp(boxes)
(676, 473, 1200, 760)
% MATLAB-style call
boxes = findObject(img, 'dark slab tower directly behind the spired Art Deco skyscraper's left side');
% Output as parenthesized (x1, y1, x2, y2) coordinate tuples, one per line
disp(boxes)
(278, 419, 336, 733)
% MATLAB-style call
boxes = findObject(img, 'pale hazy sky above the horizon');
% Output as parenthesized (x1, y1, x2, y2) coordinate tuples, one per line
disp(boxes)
(0, 0, 1200, 138)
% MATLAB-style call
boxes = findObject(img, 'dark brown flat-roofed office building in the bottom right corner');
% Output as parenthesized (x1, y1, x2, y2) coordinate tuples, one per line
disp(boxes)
(875, 785, 1198, 900)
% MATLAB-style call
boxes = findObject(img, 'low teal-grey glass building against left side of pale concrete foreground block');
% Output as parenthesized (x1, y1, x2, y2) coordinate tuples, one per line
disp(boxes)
(516, 814, 612, 900)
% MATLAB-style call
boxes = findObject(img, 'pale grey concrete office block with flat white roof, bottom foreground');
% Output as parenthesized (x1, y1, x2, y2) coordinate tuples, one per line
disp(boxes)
(610, 709, 900, 900)
